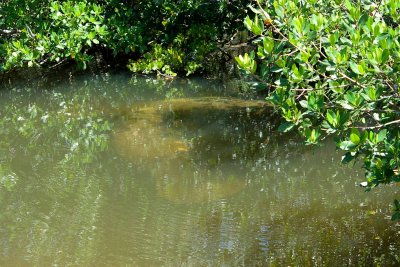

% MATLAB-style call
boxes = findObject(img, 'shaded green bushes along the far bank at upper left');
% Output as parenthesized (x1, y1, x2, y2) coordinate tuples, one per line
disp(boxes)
(0, 0, 250, 75)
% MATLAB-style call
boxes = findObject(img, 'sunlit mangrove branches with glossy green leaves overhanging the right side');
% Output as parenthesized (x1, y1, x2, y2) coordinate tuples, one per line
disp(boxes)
(237, 0, 400, 219)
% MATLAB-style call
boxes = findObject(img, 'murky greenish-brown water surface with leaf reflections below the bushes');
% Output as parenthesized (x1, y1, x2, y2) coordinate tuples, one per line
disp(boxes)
(0, 74, 400, 266)
